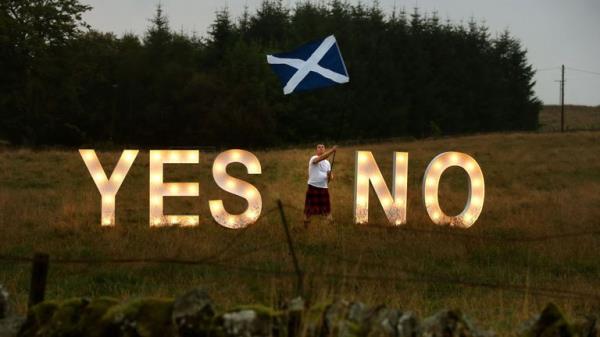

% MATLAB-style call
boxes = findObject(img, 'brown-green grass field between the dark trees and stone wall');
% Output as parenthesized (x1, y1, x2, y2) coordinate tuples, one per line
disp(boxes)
(0, 109, 600, 331)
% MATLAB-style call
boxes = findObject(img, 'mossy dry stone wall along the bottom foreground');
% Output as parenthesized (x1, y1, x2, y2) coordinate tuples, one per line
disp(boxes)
(0, 286, 600, 337)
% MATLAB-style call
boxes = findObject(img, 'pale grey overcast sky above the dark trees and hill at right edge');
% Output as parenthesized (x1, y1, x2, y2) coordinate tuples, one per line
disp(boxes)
(82, 0, 600, 105)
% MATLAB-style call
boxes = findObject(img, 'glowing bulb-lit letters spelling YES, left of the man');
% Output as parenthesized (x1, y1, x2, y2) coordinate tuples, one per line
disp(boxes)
(79, 149, 262, 228)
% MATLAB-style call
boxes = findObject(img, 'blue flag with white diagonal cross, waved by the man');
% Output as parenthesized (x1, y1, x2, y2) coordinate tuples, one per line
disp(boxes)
(267, 35, 350, 95)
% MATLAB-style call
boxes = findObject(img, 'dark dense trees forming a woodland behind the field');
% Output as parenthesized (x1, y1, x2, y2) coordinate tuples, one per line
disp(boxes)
(0, 0, 541, 147)
